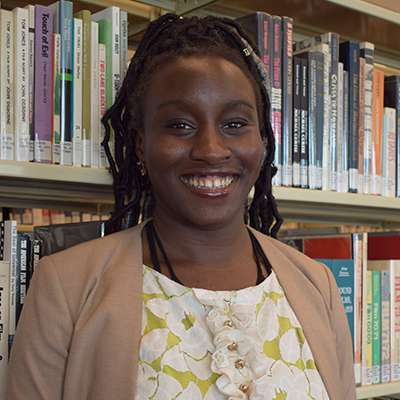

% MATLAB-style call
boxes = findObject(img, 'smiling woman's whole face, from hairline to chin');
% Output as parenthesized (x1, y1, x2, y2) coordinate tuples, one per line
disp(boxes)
(136, 57, 264, 227)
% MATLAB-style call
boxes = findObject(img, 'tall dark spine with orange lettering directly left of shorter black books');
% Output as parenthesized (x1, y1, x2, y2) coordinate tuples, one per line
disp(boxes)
(282, 17, 293, 186)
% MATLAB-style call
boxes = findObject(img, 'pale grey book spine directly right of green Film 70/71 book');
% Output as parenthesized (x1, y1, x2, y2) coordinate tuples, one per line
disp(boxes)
(381, 271, 390, 383)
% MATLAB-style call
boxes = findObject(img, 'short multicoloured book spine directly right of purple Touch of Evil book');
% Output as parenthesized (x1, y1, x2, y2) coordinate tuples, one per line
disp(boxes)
(52, 33, 61, 164)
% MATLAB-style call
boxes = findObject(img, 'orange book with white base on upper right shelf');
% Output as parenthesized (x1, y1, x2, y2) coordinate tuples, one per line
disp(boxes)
(371, 68, 385, 195)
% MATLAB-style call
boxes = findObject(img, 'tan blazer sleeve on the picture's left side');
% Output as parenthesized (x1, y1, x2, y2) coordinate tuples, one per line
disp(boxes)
(6, 257, 73, 400)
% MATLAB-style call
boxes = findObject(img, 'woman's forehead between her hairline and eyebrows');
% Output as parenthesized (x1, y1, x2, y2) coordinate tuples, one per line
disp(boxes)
(146, 56, 256, 108)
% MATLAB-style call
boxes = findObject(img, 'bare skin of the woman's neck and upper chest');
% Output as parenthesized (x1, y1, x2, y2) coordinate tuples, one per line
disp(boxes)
(142, 213, 266, 290)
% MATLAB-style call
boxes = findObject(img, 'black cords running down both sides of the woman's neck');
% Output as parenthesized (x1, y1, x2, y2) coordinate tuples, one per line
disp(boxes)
(145, 220, 272, 285)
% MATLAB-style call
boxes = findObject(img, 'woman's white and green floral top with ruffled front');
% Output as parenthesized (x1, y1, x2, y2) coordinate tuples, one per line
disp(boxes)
(136, 266, 329, 400)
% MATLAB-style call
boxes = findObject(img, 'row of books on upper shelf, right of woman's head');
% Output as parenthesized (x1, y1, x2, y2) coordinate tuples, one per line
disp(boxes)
(238, 12, 400, 197)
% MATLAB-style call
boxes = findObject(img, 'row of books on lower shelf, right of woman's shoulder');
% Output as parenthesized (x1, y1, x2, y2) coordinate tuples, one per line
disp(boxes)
(280, 231, 400, 385)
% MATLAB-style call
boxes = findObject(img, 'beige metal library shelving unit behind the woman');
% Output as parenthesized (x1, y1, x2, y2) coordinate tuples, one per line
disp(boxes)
(0, 0, 400, 399)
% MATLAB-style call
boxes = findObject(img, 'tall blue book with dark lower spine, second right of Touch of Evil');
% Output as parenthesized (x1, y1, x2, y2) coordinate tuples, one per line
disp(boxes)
(50, 0, 73, 165)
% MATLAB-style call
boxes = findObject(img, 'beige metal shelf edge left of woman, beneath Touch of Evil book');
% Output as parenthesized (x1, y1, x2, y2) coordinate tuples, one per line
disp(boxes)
(0, 160, 114, 212)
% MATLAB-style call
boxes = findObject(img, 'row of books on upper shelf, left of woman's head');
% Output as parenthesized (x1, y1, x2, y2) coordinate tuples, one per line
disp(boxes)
(0, 0, 128, 168)
